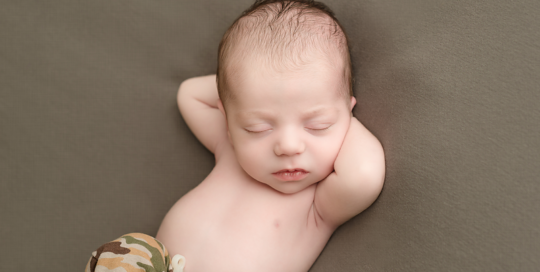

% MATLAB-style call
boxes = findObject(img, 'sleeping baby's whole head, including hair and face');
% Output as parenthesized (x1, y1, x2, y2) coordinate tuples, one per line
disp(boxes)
(217, 0, 355, 193)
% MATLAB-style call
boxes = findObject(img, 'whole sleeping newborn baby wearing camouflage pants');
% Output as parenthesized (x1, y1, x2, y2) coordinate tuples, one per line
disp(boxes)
(87, 1, 385, 272)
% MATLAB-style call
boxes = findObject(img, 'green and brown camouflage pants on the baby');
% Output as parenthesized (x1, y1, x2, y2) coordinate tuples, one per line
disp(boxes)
(84, 233, 185, 272)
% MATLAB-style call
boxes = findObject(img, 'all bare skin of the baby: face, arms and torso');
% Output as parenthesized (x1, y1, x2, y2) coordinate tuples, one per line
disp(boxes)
(156, 60, 384, 272)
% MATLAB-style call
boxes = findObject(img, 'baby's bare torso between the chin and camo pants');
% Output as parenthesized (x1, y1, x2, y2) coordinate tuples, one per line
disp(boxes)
(157, 143, 334, 272)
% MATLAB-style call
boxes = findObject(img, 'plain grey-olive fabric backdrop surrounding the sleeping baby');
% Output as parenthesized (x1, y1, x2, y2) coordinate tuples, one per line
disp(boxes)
(0, 0, 540, 272)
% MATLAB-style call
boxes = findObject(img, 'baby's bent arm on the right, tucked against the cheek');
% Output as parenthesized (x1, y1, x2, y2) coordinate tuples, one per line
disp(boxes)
(314, 117, 385, 227)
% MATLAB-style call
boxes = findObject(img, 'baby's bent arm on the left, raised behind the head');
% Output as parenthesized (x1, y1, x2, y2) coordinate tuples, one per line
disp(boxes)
(177, 75, 228, 154)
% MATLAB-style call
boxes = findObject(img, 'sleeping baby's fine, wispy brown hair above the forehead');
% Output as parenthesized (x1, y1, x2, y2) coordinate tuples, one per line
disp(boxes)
(216, 0, 353, 108)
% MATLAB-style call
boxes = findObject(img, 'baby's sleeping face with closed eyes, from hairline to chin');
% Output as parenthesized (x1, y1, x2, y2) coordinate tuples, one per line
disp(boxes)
(220, 58, 356, 193)
